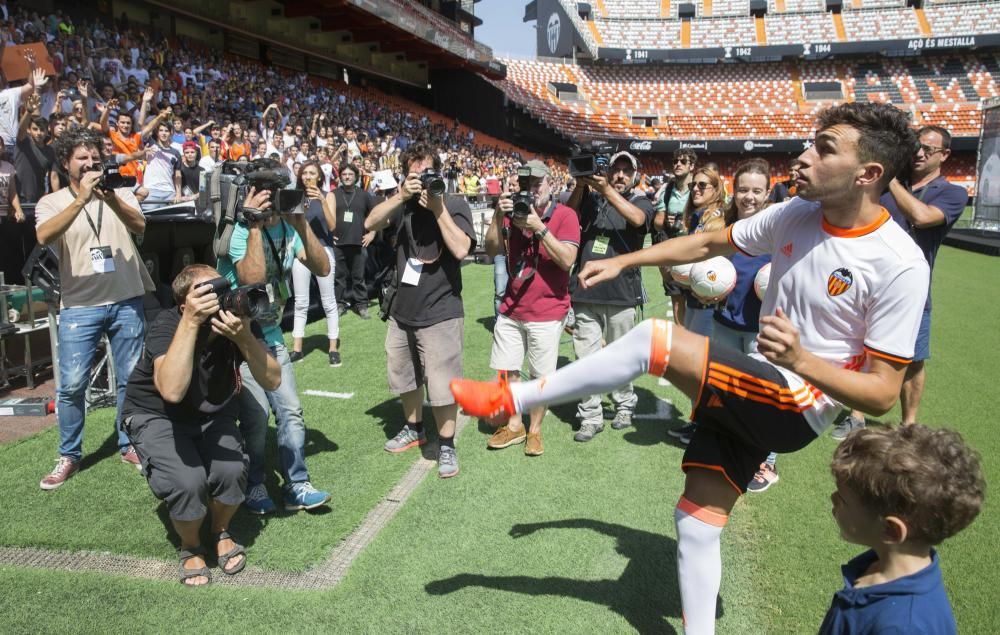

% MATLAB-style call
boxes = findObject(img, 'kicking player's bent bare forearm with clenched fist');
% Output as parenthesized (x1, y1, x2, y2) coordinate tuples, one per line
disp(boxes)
(757, 308, 906, 415)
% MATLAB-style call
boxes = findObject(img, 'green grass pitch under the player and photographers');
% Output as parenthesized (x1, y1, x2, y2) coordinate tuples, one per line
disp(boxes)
(0, 248, 1000, 633)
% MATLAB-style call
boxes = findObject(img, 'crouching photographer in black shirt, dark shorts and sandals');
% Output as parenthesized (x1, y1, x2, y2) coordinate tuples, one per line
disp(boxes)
(124, 265, 281, 586)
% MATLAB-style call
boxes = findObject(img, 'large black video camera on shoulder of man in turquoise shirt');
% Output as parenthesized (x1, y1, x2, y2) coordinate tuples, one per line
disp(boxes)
(199, 158, 305, 223)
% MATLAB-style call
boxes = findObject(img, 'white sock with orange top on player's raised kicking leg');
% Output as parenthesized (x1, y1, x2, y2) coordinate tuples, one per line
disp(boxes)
(510, 319, 673, 412)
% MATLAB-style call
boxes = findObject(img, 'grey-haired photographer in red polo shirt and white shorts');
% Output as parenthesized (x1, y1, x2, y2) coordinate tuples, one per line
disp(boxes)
(486, 161, 580, 456)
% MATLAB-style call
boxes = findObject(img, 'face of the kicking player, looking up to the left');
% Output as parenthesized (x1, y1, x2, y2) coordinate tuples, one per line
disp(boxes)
(795, 124, 865, 201)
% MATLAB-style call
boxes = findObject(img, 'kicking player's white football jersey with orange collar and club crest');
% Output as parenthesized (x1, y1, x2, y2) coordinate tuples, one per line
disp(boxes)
(729, 198, 930, 434)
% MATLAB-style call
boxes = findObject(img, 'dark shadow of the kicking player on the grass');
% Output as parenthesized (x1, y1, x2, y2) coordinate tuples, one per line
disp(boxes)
(424, 518, 681, 633)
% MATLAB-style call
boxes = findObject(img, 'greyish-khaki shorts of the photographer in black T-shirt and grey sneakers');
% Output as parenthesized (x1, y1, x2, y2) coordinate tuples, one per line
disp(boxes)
(385, 318, 465, 406)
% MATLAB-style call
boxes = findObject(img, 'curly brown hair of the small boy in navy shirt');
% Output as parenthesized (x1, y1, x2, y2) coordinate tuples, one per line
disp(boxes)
(830, 424, 986, 545)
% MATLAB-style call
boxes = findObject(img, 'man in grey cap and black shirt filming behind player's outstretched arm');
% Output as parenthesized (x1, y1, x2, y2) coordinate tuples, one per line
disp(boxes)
(567, 152, 654, 442)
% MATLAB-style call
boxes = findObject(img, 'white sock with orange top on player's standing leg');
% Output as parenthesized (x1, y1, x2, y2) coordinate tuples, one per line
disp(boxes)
(674, 496, 729, 635)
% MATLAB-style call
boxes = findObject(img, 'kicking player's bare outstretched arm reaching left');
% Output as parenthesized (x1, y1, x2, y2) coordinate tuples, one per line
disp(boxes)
(579, 230, 736, 289)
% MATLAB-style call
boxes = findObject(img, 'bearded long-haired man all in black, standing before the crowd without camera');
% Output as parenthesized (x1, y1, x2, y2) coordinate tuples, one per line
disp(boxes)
(333, 163, 375, 320)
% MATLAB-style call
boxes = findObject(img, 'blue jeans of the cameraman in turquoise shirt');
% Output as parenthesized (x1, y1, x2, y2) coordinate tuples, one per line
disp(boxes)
(240, 344, 309, 489)
